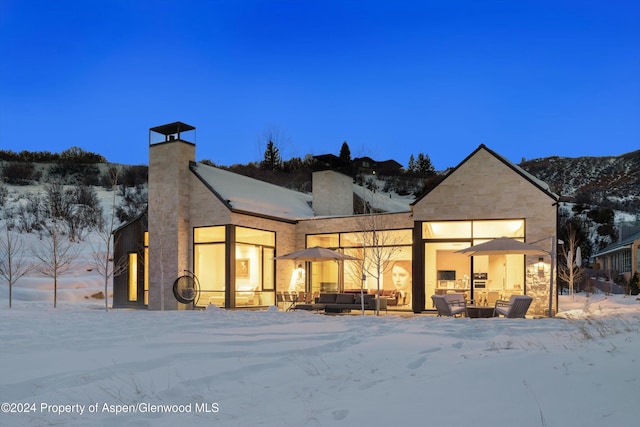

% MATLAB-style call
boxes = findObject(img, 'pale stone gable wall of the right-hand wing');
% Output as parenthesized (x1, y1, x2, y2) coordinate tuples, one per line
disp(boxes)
(413, 146, 557, 315)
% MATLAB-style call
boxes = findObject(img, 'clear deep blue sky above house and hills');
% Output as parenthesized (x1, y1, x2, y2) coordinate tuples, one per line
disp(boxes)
(0, 0, 640, 169)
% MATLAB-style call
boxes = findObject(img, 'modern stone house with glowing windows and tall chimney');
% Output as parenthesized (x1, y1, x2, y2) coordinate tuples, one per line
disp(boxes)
(114, 122, 558, 315)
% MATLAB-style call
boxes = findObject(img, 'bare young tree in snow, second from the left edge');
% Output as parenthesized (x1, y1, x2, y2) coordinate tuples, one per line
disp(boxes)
(34, 218, 79, 308)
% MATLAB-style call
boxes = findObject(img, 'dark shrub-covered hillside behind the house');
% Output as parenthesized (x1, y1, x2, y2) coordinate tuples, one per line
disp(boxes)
(0, 148, 640, 253)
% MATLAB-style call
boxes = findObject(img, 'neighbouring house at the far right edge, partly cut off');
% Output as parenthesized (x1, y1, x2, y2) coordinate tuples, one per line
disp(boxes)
(593, 231, 640, 281)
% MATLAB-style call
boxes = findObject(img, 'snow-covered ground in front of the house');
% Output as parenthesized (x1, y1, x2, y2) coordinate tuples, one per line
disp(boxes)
(0, 256, 640, 427)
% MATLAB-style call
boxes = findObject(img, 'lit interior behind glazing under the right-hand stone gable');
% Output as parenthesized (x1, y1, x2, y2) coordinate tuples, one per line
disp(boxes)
(422, 219, 525, 309)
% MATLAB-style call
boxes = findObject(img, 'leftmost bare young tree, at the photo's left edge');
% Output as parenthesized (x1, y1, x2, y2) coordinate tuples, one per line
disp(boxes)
(0, 218, 34, 308)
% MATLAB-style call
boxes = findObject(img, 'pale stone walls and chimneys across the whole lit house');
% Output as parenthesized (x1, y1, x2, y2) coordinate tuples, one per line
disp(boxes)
(130, 129, 557, 315)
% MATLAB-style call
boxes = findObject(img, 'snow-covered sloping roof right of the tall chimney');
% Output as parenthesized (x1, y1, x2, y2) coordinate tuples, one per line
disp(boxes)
(192, 163, 314, 220)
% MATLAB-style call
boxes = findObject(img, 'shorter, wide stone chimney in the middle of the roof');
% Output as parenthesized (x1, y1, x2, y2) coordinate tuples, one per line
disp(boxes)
(312, 170, 353, 216)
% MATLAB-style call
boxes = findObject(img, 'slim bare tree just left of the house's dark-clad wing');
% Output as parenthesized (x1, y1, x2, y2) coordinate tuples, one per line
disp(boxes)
(91, 166, 127, 311)
